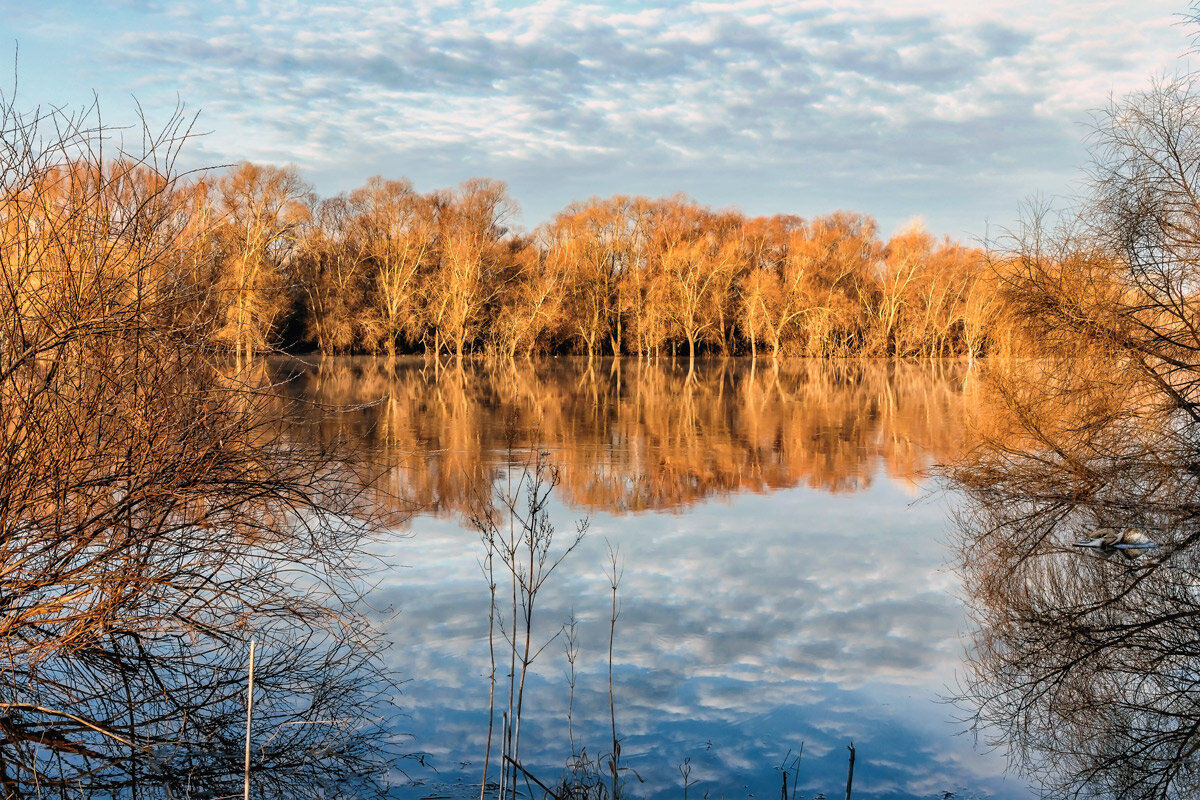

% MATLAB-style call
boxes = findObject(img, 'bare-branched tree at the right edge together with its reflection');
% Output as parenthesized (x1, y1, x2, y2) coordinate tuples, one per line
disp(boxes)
(956, 64, 1200, 798)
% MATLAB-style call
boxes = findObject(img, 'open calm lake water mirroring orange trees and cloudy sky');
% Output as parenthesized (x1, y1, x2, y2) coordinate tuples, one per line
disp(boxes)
(280, 360, 1032, 799)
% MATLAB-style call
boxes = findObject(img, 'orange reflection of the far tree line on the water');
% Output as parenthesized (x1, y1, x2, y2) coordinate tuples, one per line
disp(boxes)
(282, 359, 970, 511)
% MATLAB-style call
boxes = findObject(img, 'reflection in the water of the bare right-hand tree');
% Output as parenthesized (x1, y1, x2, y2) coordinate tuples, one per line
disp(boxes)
(955, 356, 1200, 798)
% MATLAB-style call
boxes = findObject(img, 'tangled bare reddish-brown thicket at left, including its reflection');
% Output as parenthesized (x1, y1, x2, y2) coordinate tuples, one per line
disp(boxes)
(0, 97, 403, 798)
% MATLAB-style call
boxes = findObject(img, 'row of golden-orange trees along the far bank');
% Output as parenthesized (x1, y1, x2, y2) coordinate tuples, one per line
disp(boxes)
(82, 163, 1010, 361)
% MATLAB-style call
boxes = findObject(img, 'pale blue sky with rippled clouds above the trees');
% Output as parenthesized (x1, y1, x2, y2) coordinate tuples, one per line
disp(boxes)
(0, 0, 1200, 242)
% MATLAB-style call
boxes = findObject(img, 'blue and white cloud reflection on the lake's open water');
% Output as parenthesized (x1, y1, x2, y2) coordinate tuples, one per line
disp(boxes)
(385, 482, 1024, 796)
